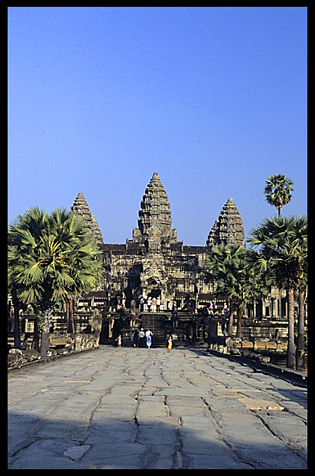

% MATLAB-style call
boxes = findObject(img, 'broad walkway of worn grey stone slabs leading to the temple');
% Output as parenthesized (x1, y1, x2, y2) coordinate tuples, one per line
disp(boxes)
(8, 346, 307, 469)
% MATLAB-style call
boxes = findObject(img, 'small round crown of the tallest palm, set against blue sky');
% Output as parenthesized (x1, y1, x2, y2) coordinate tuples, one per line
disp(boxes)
(265, 174, 294, 217)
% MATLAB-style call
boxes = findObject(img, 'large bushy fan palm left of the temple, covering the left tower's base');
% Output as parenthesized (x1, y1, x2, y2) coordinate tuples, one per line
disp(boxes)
(8, 207, 101, 356)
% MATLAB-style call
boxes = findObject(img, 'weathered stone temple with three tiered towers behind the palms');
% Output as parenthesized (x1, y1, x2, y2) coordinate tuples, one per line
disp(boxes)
(8, 172, 304, 345)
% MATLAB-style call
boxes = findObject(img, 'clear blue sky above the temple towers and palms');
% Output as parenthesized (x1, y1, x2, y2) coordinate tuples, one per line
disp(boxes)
(8, 7, 307, 245)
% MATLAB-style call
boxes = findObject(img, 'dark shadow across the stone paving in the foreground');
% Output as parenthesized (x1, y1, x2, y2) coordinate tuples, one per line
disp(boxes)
(8, 412, 306, 469)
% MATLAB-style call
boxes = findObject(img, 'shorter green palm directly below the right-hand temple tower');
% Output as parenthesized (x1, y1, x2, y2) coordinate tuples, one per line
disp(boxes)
(206, 244, 268, 337)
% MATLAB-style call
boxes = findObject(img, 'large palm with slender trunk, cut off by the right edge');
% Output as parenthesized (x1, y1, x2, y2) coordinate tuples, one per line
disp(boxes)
(248, 216, 307, 368)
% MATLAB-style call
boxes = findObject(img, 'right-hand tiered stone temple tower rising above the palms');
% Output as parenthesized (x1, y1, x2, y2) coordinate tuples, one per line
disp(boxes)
(207, 198, 245, 246)
